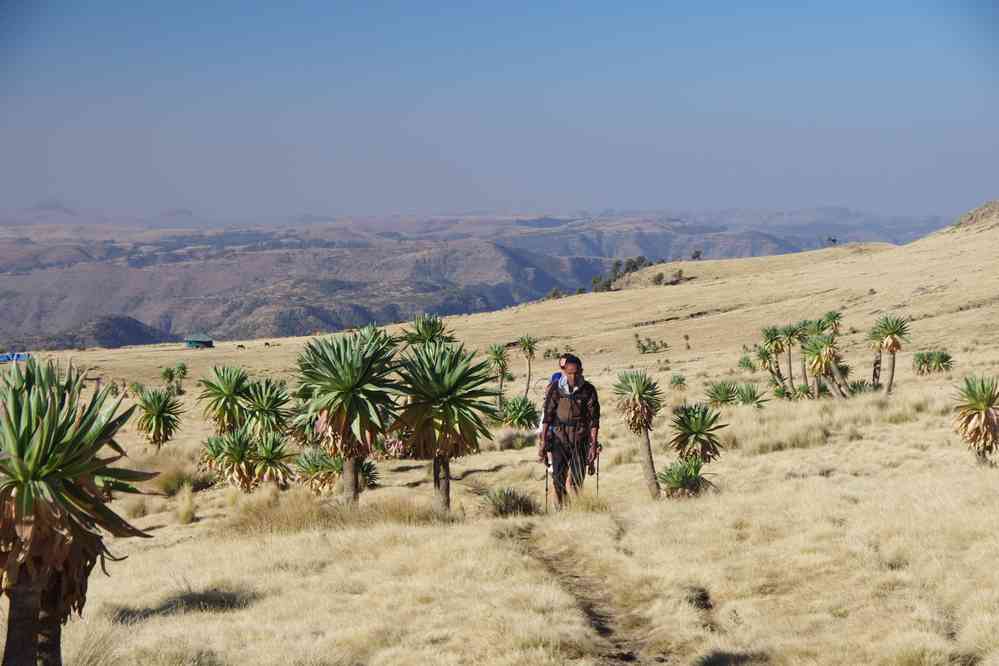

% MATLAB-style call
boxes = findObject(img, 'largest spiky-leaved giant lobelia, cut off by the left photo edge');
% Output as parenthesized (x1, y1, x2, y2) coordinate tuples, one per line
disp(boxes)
(0, 359, 156, 666)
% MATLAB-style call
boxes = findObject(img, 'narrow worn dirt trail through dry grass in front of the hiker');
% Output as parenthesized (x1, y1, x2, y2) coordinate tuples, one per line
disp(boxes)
(498, 523, 668, 664)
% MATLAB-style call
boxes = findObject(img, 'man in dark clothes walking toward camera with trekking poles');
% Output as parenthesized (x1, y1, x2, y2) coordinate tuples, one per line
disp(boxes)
(538, 354, 600, 508)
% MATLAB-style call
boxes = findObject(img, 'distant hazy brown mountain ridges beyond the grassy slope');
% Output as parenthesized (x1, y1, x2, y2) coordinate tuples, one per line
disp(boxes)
(0, 202, 951, 348)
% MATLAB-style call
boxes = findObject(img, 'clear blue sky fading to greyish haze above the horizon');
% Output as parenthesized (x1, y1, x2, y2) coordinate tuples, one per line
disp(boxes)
(0, 0, 999, 216)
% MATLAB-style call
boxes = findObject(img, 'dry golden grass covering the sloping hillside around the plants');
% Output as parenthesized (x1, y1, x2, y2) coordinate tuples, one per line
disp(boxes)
(11, 217, 999, 666)
